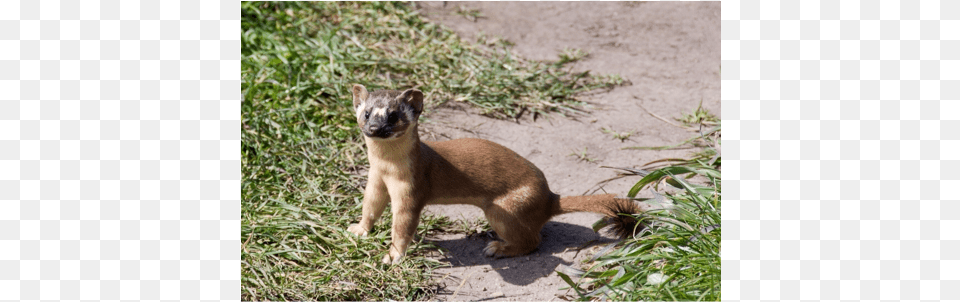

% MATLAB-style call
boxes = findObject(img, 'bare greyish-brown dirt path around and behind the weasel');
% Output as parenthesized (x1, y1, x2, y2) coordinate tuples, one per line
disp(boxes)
(408, 2, 720, 301)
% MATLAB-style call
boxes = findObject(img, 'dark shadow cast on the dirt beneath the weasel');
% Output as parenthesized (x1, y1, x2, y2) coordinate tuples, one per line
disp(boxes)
(425, 221, 617, 286)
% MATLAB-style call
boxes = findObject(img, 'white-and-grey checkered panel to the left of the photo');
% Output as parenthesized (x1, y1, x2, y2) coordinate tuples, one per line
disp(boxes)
(0, 0, 240, 301)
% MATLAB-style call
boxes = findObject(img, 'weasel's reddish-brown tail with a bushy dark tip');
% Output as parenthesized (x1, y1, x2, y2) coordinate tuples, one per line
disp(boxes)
(557, 194, 643, 238)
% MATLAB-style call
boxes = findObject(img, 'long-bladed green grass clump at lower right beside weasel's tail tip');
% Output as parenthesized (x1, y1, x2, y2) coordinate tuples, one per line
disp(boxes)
(557, 109, 721, 301)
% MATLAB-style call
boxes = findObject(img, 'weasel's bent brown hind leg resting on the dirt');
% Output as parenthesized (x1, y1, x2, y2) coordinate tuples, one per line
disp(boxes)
(483, 205, 543, 258)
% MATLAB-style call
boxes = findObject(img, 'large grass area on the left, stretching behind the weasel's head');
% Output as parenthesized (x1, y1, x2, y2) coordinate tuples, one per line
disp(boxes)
(241, 2, 622, 300)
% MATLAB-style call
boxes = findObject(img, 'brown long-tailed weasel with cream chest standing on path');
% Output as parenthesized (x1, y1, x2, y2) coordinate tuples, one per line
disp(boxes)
(348, 85, 640, 263)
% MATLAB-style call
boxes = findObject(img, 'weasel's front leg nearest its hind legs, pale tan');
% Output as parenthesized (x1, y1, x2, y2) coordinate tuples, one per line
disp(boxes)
(383, 183, 423, 264)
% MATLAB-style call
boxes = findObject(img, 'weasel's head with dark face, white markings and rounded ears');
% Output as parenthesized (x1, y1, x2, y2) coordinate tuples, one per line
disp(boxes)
(353, 84, 423, 140)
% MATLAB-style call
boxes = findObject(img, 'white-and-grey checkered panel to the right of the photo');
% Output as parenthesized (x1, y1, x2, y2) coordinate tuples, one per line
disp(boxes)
(721, 0, 960, 301)
